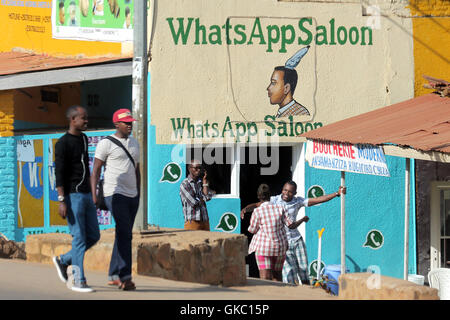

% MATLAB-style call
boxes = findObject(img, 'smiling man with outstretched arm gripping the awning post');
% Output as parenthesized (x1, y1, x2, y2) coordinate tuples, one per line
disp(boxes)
(241, 181, 347, 285)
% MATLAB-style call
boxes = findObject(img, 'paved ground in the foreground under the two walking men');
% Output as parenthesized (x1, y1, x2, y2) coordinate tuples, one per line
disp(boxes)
(0, 259, 338, 300)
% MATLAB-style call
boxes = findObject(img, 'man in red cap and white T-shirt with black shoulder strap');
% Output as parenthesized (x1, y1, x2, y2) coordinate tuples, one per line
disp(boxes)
(91, 109, 140, 290)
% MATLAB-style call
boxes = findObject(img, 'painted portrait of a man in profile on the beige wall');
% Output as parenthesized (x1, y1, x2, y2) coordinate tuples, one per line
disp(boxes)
(267, 66, 310, 118)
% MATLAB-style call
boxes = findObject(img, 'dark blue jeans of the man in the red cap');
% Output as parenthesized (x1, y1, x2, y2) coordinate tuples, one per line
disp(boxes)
(105, 193, 139, 281)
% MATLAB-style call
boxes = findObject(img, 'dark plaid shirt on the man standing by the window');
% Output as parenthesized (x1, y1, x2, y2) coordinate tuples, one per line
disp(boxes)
(180, 176, 212, 221)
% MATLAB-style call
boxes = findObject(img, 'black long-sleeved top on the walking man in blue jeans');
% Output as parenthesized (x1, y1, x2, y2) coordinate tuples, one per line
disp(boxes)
(55, 132, 91, 195)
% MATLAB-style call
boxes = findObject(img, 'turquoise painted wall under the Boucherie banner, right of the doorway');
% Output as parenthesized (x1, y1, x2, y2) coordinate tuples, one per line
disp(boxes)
(305, 156, 416, 278)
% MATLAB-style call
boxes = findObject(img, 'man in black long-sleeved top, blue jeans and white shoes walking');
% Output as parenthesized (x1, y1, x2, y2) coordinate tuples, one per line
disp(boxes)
(53, 106, 100, 292)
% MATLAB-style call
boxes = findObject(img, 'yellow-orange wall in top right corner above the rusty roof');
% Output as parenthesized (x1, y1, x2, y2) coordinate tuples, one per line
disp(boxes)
(409, 0, 450, 96)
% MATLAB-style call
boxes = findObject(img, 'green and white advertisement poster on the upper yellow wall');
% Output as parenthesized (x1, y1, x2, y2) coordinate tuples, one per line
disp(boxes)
(52, 0, 133, 42)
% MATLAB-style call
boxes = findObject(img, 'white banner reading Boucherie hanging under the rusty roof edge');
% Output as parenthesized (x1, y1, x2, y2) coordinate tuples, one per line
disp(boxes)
(305, 140, 390, 177)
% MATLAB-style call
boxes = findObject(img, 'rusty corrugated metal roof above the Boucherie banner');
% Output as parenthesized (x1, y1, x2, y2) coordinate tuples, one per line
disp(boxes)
(301, 93, 450, 153)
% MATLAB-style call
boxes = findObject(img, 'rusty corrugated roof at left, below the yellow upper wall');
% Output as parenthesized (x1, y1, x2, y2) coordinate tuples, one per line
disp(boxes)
(0, 51, 131, 75)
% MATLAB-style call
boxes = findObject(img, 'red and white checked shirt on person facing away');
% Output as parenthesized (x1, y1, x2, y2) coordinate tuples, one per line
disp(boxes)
(248, 202, 293, 256)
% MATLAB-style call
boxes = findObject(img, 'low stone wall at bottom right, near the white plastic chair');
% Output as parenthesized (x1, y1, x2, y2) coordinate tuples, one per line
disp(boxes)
(339, 273, 439, 300)
